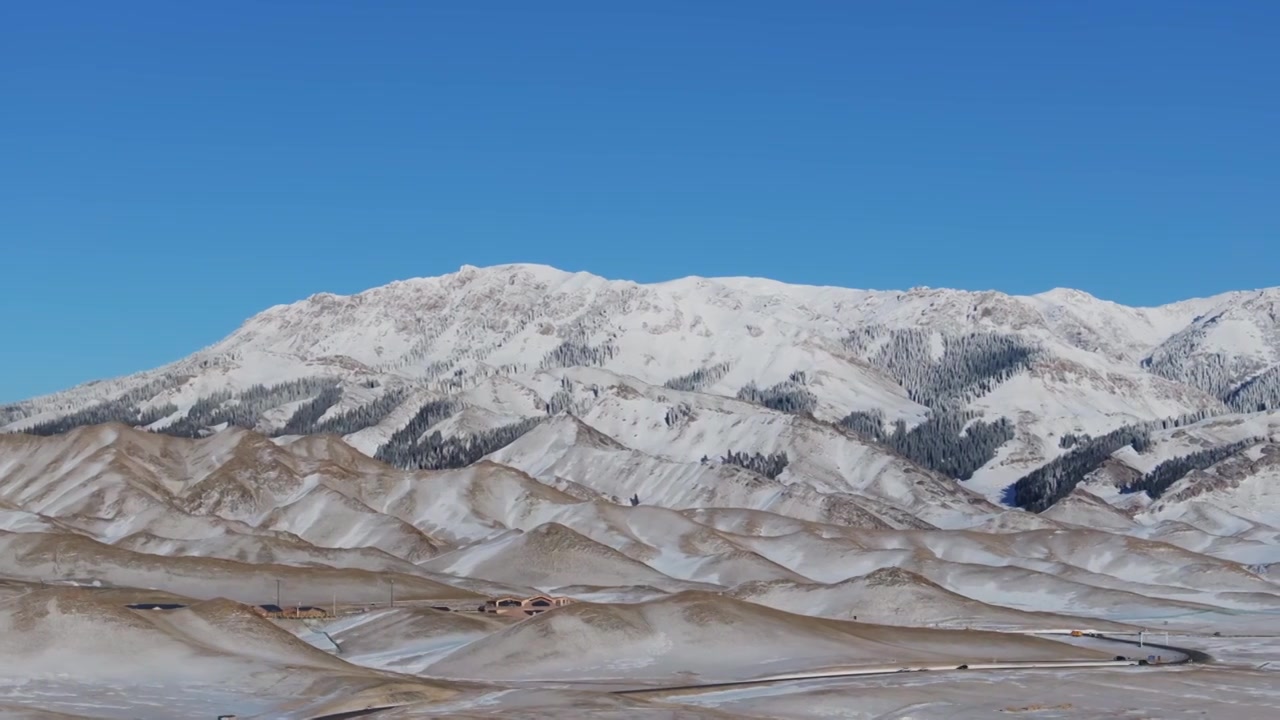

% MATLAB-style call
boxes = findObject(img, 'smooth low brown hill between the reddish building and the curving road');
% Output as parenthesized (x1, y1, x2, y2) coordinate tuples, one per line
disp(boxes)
(430, 592, 1101, 682)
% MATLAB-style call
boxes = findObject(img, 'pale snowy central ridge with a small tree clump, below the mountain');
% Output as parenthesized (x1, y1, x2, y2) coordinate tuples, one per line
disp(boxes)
(492, 414, 977, 528)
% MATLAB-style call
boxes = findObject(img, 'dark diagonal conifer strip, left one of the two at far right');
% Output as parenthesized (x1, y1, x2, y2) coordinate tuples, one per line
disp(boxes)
(1005, 425, 1151, 512)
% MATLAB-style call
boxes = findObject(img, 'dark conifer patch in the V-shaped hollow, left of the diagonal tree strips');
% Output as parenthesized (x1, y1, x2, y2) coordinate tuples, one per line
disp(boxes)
(840, 410, 1014, 480)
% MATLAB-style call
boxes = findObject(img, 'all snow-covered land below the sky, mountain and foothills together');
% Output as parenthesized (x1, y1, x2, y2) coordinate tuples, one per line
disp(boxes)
(0, 265, 1280, 720)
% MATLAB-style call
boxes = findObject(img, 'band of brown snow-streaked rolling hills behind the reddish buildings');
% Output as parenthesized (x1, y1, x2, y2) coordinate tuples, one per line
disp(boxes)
(0, 422, 1280, 625)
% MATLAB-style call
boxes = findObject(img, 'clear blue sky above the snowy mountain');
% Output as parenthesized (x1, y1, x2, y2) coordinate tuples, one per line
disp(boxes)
(0, 0, 1280, 401)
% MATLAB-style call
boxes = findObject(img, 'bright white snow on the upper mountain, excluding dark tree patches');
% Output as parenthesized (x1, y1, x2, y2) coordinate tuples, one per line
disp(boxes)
(0, 265, 1280, 509)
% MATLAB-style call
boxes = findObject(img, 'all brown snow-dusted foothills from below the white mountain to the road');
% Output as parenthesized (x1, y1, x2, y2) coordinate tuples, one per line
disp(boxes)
(0, 417, 1280, 720)
